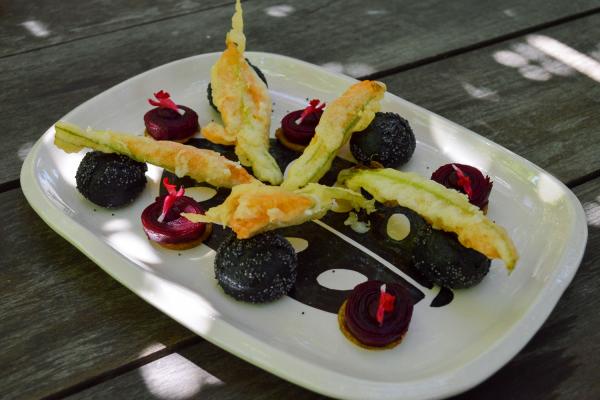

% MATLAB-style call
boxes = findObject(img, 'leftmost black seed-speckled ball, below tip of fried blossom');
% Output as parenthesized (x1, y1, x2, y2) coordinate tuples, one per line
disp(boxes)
(75, 151, 148, 208)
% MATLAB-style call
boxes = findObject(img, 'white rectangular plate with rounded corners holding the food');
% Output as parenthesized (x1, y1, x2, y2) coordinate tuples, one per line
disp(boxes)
(21, 53, 587, 399)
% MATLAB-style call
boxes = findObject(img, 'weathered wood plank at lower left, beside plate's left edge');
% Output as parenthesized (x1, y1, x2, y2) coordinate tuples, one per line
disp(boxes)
(0, 190, 195, 398)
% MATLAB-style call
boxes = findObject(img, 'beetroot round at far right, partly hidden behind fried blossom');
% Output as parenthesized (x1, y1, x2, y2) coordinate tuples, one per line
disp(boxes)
(431, 163, 493, 211)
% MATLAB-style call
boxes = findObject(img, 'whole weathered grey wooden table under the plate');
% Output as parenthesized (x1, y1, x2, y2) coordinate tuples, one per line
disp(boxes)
(0, 0, 600, 399)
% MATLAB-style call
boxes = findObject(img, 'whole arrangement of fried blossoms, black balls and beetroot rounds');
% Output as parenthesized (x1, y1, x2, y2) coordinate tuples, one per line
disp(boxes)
(48, 1, 518, 349)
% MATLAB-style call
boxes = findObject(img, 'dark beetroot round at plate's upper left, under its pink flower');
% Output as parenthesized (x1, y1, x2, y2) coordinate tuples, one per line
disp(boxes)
(144, 106, 200, 140)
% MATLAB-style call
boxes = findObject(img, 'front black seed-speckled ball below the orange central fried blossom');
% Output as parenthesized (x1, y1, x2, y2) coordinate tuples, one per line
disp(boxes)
(215, 232, 298, 303)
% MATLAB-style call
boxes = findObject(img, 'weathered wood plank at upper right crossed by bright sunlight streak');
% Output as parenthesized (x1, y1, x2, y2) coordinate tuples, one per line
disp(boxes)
(382, 15, 600, 182)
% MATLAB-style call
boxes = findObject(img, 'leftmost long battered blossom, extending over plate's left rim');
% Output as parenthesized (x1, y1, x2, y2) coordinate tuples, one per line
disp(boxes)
(54, 121, 256, 187)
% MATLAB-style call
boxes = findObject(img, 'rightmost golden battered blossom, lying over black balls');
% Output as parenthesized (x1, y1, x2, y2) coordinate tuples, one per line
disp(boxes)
(338, 168, 519, 270)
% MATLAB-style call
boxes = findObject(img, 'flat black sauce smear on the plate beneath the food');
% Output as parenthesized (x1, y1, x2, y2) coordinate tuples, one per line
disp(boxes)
(161, 138, 454, 314)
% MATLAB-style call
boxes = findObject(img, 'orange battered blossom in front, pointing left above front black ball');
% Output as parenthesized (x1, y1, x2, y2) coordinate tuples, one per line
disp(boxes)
(182, 183, 374, 239)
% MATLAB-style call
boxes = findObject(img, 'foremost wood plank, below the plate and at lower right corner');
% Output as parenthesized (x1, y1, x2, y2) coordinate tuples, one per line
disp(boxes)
(61, 179, 600, 400)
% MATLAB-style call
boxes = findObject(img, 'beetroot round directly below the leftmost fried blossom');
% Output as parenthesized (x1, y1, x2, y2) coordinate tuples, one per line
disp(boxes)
(142, 196, 206, 244)
